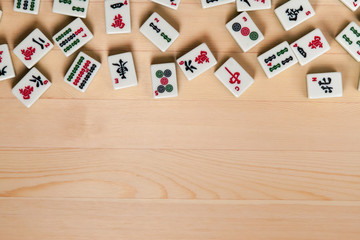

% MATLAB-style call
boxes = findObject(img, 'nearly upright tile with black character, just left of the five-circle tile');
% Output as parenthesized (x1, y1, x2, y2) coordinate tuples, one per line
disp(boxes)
(108, 52, 137, 90)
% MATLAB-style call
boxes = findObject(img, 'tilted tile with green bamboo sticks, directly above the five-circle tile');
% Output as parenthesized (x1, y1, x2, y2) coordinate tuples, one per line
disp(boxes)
(140, 12, 179, 52)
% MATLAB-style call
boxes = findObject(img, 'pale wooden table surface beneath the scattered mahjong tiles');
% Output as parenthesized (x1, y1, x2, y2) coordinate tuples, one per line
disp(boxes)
(0, 0, 360, 240)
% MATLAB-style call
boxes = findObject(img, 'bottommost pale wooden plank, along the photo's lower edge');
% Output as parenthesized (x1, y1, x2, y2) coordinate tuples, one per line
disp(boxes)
(0, 199, 360, 240)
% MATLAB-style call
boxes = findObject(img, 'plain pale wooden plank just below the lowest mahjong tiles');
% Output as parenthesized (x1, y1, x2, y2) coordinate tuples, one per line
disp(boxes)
(0, 99, 360, 151)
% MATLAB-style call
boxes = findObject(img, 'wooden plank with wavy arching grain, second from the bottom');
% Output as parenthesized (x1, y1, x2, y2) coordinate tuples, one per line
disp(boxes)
(0, 149, 360, 200)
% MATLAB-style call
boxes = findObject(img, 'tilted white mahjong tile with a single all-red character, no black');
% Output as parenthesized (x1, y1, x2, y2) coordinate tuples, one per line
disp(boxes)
(215, 58, 254, 97)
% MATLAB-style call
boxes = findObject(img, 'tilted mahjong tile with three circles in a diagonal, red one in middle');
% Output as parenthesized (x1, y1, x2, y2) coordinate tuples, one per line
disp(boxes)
(226, 12, 264, 52)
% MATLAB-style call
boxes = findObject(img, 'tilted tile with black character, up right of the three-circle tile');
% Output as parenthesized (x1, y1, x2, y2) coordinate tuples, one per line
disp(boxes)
(275, 0, 315, 31)
